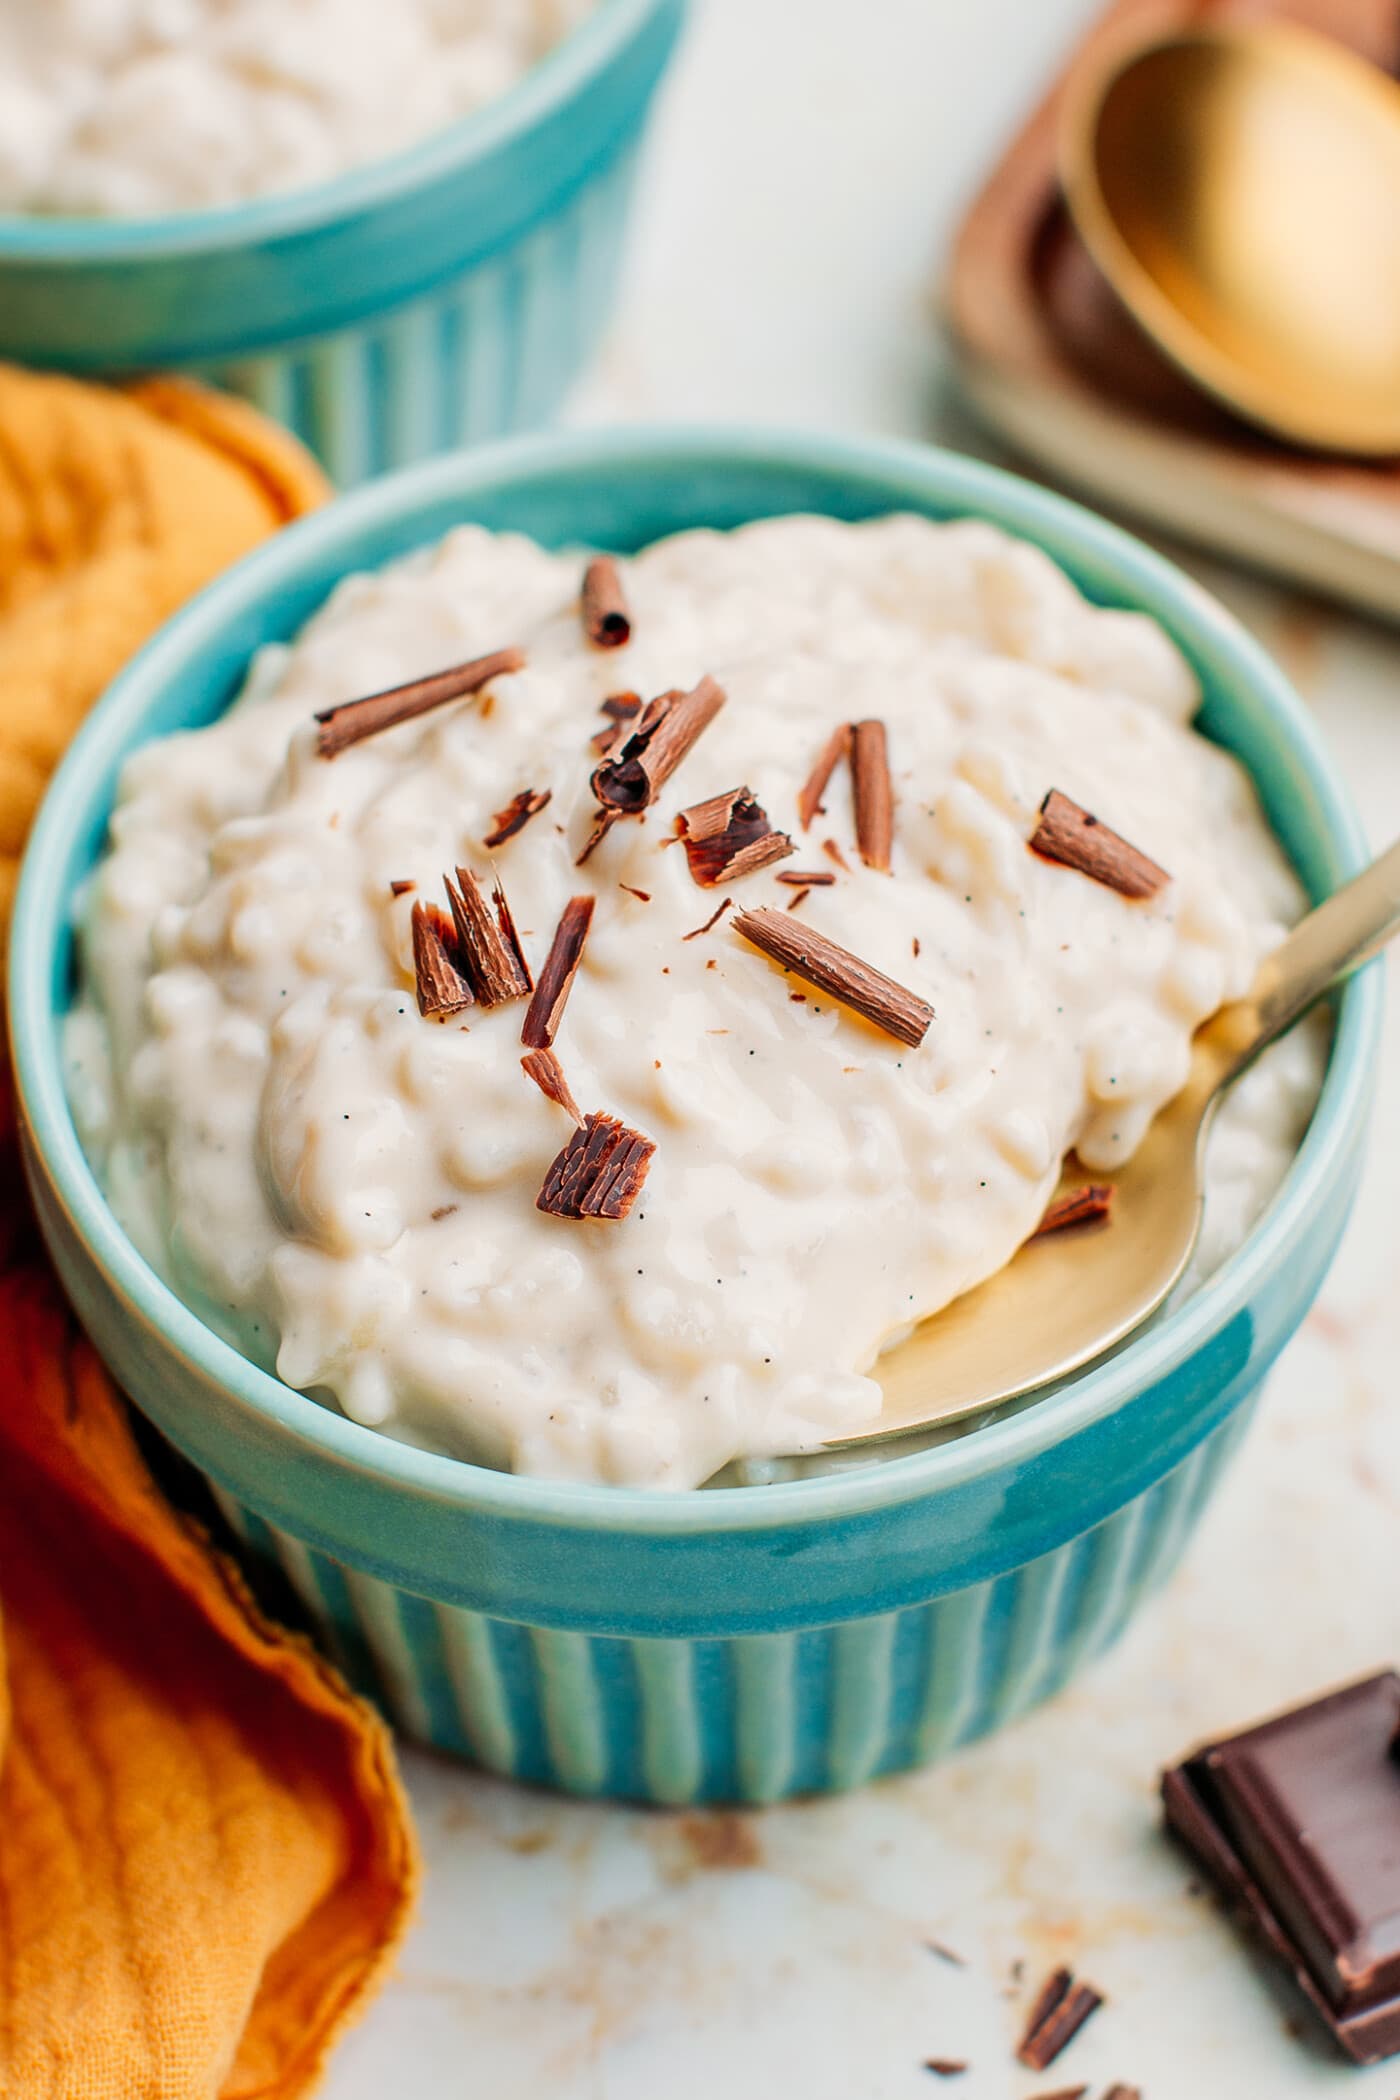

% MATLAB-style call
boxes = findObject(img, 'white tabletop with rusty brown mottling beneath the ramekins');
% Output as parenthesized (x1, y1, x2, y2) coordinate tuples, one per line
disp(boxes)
(325, 0, 1400, 2100)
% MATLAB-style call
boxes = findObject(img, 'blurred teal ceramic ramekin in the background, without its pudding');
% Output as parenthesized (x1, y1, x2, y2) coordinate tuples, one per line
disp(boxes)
(0, 0, 684, 487)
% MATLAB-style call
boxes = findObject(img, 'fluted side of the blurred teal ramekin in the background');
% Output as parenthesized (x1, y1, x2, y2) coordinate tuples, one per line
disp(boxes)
(203, 141, 638, 487)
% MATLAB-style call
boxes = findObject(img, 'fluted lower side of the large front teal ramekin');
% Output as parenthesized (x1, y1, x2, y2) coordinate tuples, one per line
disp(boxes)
(205, 1388, 1257, 1806)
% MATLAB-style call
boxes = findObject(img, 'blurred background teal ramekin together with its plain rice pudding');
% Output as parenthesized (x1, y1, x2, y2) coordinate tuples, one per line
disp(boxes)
(0, 0, 684, 483)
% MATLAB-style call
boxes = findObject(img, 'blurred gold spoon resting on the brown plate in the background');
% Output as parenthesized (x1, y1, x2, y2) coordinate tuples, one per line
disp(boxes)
(1060, 23, 1400, 456)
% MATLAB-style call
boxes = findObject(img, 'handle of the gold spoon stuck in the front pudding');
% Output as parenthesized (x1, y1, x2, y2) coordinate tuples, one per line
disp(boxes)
(1219, 840, 1400, 1082)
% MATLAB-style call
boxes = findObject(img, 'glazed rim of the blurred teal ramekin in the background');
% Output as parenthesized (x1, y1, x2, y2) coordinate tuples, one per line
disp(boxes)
(0, 0, 657, 267)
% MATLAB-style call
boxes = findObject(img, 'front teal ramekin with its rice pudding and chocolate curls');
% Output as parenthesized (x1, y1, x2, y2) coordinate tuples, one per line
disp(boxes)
(10, 433, 1379, 1802)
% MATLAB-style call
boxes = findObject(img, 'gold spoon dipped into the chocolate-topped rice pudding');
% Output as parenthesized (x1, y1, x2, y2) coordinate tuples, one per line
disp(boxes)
(825, 842, 1400, 1451)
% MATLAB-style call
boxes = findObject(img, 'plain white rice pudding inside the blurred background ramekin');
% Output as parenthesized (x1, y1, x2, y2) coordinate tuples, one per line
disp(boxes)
(0, 0, 596, 218)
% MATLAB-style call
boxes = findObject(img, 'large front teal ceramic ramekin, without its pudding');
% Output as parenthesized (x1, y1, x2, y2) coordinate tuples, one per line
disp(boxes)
(10, 431, 1381, 1802)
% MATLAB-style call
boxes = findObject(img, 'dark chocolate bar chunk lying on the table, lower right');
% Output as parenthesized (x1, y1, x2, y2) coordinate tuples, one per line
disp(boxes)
(1163, 1670, 1400, 2064)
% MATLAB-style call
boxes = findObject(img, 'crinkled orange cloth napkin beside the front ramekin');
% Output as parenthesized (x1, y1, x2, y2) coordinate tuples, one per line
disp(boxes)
(0, 365, 418, 2100)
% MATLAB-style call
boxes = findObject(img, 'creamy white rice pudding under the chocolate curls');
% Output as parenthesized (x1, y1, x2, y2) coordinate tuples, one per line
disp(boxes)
(69, 517, 1320, 1487)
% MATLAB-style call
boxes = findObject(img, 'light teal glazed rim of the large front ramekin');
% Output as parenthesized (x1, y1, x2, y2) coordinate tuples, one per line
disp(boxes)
(8, 426, 1381, 1535)
